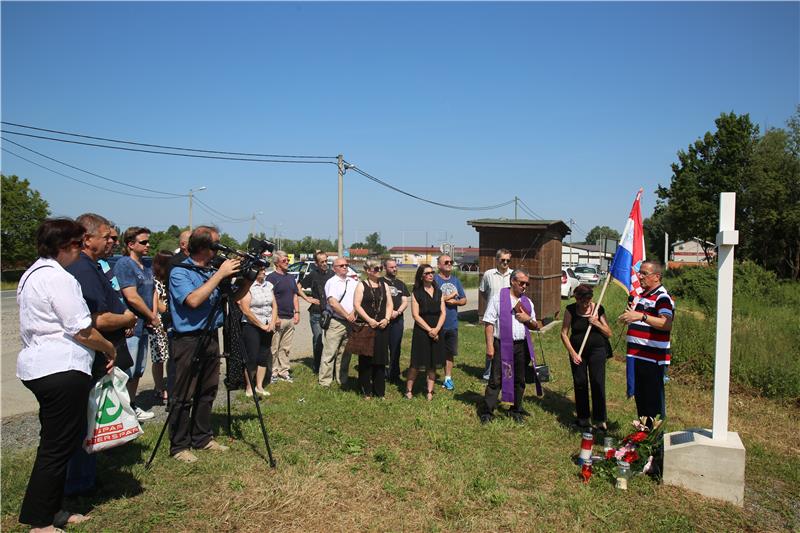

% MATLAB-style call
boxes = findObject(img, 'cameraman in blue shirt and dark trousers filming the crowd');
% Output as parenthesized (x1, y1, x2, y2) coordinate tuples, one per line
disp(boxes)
(169, 226, 252, 463)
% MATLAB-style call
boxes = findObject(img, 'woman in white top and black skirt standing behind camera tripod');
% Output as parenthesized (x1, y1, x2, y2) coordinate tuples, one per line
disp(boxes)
(239, 268, 278, 397)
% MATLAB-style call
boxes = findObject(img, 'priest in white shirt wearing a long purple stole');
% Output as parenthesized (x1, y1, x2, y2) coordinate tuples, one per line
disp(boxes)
(480, 269, 542, 423)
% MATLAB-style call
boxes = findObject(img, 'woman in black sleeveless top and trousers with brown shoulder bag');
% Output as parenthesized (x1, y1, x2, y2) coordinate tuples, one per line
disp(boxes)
(353, 259, 394, 400)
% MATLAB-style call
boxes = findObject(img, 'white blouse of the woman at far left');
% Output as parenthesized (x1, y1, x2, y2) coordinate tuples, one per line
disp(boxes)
(17, 258, 94, 381)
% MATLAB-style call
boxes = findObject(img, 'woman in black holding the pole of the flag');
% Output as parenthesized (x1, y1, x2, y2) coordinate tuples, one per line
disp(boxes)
(561, 285, 611, 430)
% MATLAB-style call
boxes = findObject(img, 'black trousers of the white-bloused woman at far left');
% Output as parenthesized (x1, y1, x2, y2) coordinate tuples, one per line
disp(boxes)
(19, 370, 92, 527)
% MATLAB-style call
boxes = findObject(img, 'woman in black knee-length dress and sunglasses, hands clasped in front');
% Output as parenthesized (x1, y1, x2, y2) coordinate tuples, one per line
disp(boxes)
(406, 264, 445, 401)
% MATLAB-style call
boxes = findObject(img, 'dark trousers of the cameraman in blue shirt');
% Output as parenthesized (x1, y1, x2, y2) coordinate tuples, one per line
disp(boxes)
(169, 331, 219, 455)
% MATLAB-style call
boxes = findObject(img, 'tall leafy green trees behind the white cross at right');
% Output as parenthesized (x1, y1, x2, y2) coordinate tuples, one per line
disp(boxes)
(656, 111, 800, 279)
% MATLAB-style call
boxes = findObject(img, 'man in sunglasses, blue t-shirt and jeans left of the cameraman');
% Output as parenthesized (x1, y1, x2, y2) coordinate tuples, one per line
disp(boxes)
(114, 226, 161, 421)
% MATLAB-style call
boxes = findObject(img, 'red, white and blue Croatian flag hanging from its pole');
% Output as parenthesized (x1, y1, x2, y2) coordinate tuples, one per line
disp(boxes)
(608, 189, 645, 398)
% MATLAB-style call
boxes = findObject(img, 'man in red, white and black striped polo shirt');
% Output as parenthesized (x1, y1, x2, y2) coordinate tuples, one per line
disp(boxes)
(619, 261, 675, 417)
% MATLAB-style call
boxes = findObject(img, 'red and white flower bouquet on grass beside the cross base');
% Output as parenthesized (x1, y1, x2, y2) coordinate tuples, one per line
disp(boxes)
(592, 416, 664, 482)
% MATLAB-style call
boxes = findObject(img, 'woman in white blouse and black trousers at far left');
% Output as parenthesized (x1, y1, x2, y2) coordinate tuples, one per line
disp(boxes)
(17, 219, 116, 531)
